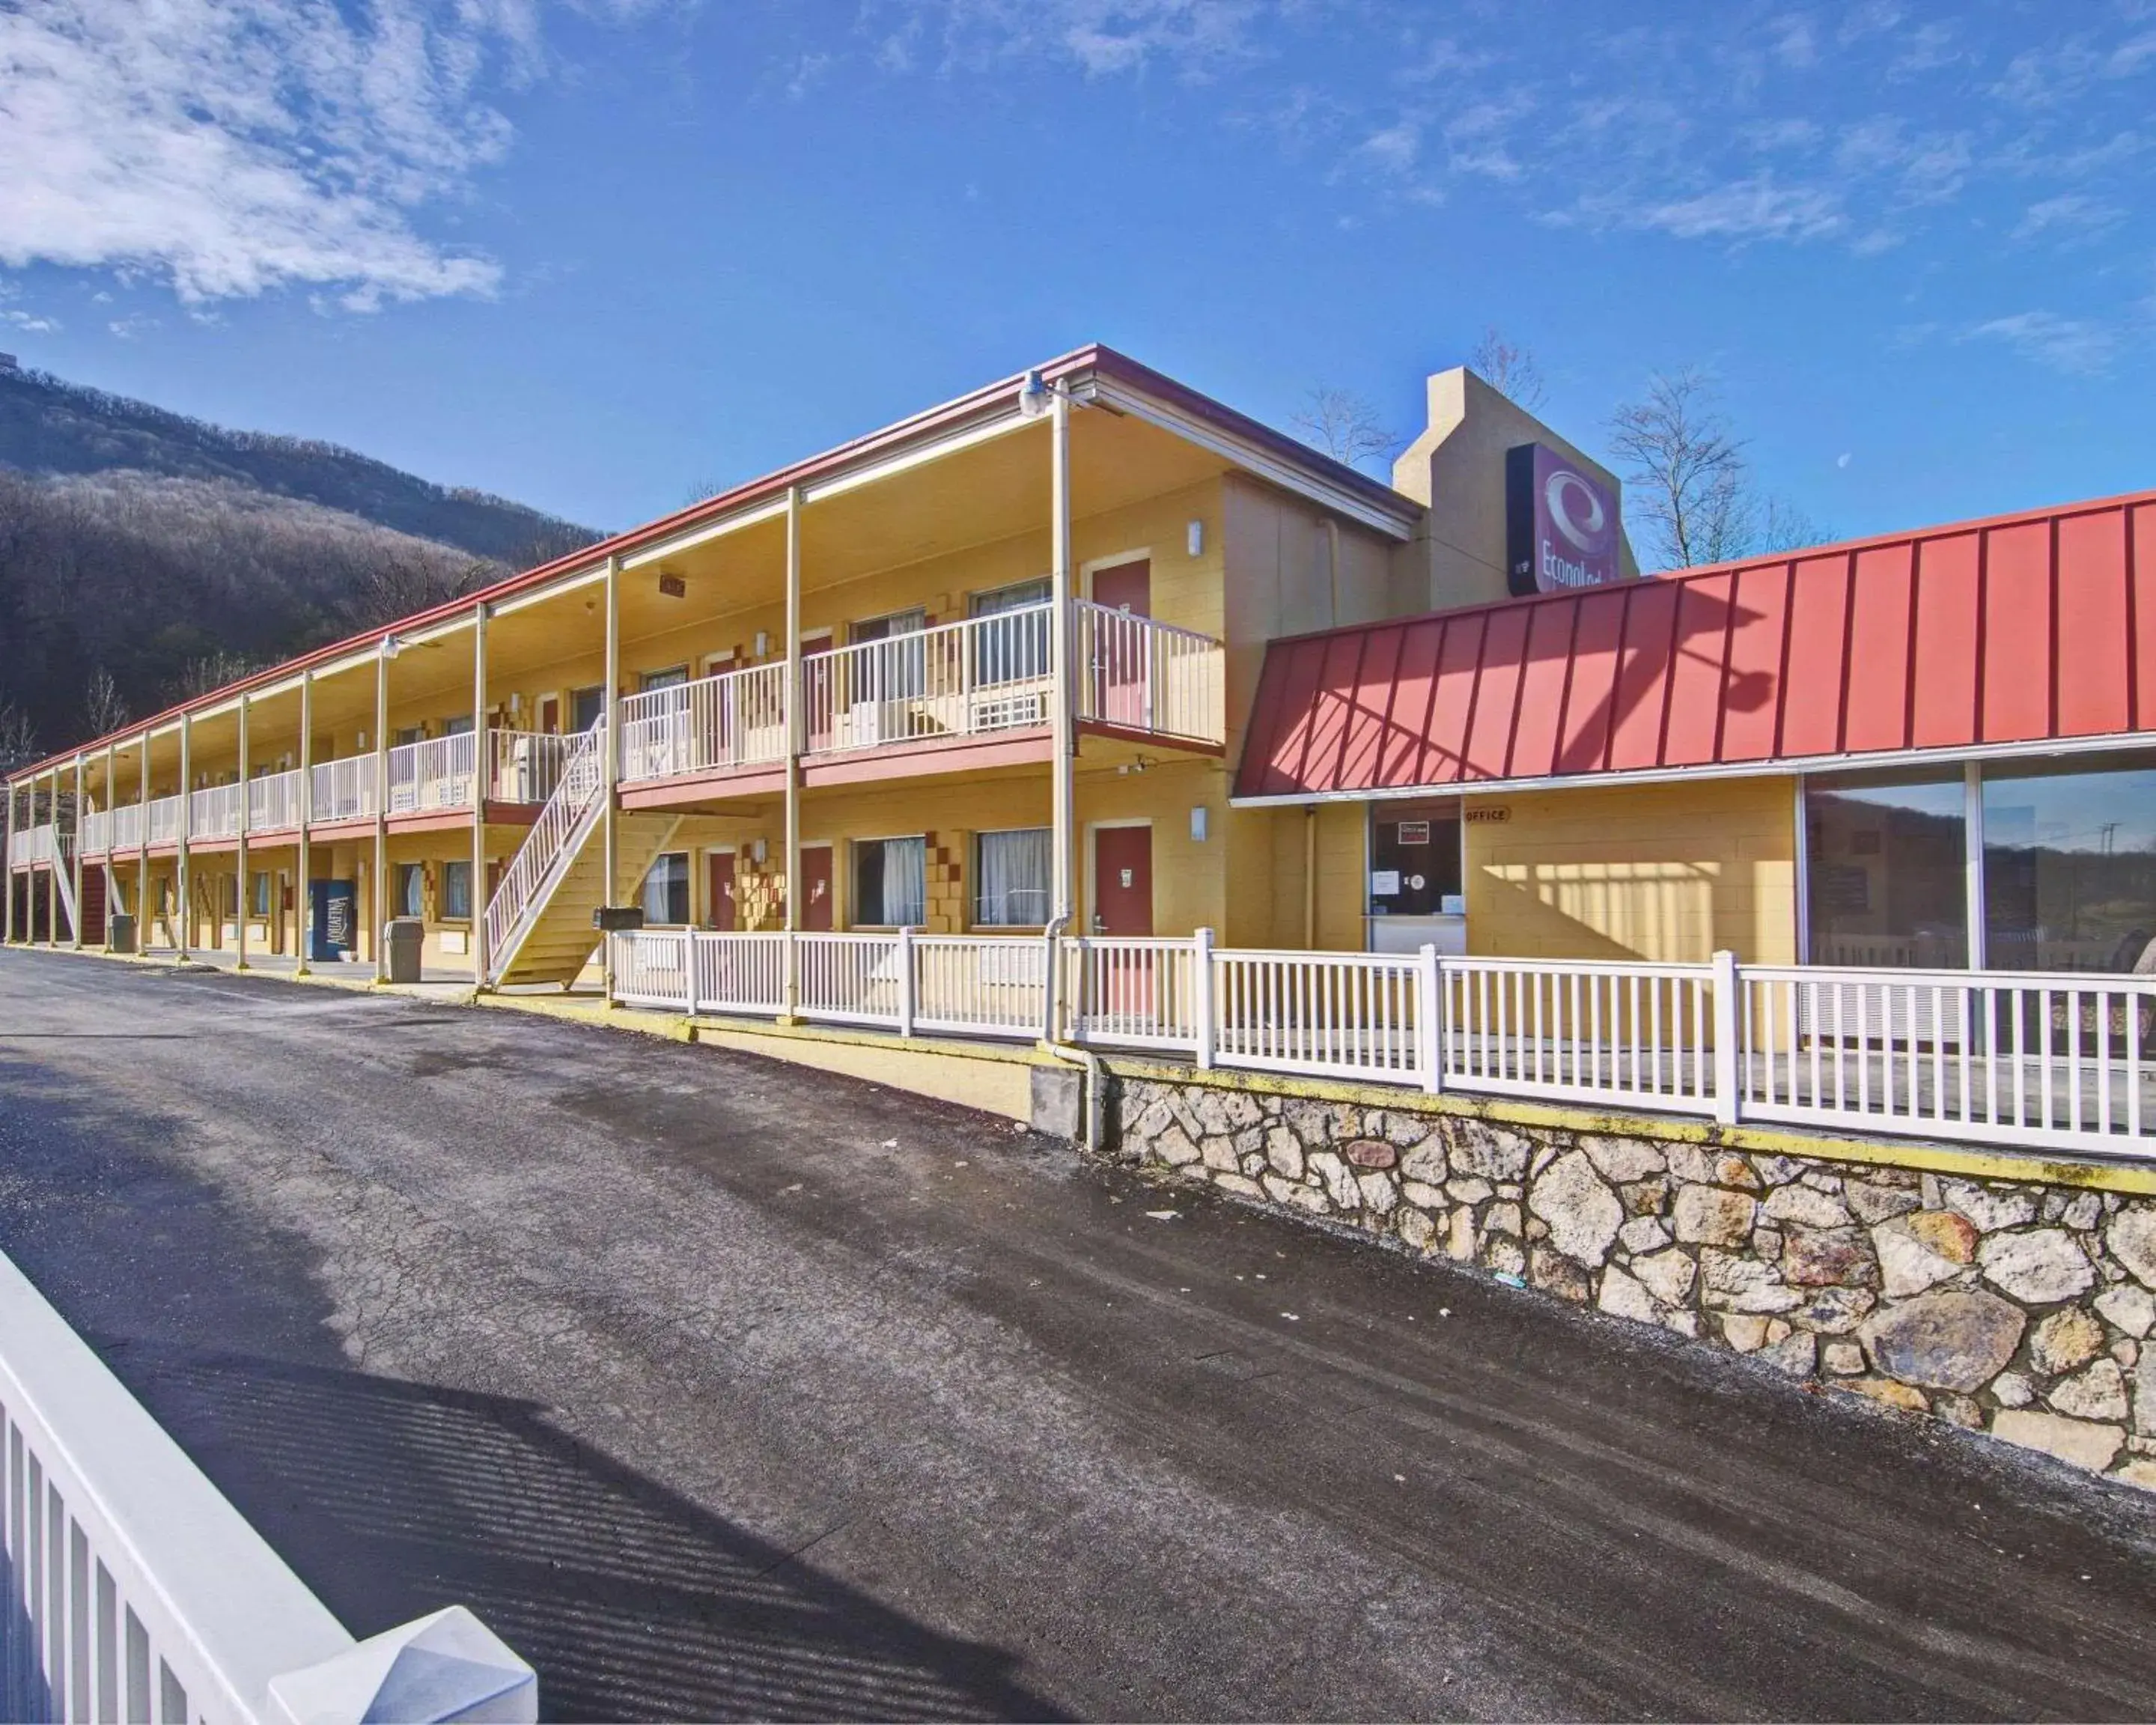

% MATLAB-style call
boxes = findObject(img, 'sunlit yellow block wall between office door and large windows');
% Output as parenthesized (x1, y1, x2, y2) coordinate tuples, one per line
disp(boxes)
(1466, 779, 1796, 964)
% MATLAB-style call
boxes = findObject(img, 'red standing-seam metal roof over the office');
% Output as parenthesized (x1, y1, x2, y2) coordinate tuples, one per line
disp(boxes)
(1235, 492, 2156, 798)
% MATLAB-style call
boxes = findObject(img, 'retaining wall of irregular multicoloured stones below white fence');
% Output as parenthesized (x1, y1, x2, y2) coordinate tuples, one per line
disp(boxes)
(1108, 1074, 2156, 1488)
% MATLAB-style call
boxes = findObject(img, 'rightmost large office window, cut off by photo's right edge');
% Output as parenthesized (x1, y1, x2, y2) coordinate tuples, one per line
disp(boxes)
(1984, 757, 2156, 973)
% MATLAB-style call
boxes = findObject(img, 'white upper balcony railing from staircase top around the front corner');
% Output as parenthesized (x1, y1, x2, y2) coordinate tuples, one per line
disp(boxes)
(621, 600, 1225, 809)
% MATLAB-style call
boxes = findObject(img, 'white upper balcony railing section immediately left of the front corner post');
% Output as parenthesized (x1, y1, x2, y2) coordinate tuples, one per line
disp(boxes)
(802, 606, 1054, 755)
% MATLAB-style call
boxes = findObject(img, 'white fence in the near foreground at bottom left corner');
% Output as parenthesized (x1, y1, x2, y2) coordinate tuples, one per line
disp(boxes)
(0, 1257, 539, 1725)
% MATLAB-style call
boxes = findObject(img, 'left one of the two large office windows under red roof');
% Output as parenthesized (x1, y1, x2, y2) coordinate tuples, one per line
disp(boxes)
(1805, 765, 1968, 970)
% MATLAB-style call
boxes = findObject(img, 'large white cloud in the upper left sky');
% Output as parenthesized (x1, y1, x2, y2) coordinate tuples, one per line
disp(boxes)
(0, 0, 547, 305)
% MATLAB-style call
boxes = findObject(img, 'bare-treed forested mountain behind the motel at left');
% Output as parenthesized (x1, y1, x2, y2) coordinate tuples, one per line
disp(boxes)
(0, 371, 600, 764)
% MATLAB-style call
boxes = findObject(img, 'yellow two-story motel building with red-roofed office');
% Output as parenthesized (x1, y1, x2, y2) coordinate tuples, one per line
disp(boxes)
(7, 347, 2156, 1039)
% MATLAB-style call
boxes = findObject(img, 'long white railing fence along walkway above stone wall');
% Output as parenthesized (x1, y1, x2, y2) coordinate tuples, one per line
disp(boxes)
(612, 929, 2156, 1156)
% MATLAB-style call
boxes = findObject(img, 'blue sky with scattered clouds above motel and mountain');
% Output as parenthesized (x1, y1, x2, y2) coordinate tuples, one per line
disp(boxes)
(0, 0, 2156, 535)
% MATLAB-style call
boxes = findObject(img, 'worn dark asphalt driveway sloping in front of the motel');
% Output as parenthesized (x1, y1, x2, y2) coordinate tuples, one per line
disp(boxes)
(0, 951, 2156, 1718)
